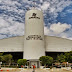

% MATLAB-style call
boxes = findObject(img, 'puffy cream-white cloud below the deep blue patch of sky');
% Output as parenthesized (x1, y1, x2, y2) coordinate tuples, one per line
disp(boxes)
(50, 22, 71, 34)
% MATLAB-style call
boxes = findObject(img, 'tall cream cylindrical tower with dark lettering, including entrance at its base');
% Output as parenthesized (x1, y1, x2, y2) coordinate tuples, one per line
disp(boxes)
(23, 8, 45, 67)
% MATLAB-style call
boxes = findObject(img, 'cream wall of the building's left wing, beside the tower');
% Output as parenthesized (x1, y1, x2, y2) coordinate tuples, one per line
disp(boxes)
(0, 36, 24, 52)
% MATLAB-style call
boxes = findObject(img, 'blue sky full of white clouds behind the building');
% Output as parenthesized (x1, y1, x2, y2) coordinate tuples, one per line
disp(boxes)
(0, 0, 72, 40)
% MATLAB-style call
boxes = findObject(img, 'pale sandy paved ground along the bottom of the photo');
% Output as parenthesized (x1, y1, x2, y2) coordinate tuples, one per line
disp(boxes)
(0, 68, 72, 72)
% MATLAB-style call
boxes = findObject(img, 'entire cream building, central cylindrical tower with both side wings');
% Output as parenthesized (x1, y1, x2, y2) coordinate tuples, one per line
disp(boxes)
(0, 9, 72, 67)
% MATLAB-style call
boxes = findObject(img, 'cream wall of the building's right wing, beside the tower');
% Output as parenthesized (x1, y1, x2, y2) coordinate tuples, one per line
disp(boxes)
(45, 36, 72, 52)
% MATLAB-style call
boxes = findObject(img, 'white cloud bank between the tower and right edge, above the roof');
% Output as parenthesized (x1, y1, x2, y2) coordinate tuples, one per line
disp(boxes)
(44, 22, 72, 39)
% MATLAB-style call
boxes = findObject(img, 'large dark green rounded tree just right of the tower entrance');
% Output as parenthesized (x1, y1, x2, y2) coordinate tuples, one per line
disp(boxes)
(39, 56, 53, 66)
